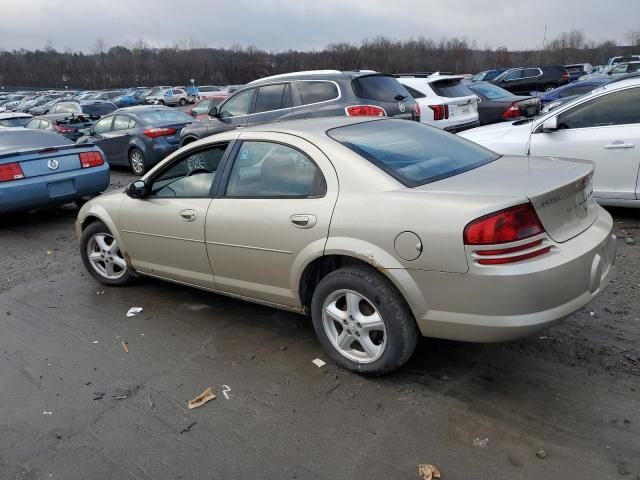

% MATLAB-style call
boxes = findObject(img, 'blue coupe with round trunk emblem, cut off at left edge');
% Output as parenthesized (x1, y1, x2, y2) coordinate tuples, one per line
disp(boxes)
(0, 128, 109, 213)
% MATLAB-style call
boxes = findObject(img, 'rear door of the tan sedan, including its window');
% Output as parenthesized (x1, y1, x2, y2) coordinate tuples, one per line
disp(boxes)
(206, 132, 338, 306)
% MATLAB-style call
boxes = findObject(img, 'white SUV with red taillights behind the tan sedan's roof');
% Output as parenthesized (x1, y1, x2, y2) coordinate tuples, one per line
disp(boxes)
(398, 73, 480, 133)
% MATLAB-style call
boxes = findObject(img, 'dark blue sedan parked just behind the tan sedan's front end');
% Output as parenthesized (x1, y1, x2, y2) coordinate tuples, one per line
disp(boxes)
(78, 105, 194, 175)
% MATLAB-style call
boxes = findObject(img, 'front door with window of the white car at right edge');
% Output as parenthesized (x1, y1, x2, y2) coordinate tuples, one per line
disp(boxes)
(530, 87, 640, 200)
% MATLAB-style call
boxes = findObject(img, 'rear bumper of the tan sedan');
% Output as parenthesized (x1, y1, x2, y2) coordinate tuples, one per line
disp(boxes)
(410, 209, 616, 342)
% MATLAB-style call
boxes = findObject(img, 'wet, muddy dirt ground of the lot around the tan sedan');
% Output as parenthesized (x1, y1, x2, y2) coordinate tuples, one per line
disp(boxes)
(0, 170, 640, 480)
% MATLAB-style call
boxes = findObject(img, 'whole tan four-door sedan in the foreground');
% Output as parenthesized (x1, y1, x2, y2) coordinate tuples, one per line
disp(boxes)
(77, 118, 616, 374)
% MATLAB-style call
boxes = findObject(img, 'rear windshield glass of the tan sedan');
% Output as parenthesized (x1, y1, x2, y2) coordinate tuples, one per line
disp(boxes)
(327, 120, 499, 187)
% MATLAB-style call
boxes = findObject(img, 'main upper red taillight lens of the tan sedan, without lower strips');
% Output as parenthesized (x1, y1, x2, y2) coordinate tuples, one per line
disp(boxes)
(464, 203, 544, 245)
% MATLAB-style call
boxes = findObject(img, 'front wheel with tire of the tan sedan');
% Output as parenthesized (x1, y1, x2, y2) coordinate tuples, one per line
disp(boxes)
(80, 222, 135, 286)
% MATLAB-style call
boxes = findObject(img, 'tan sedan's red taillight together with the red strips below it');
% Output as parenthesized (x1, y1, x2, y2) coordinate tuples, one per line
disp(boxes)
(464, 203, 551, 265)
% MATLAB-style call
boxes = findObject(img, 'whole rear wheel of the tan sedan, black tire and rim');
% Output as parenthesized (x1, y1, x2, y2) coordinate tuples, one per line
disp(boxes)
(311, 267, 418, 375)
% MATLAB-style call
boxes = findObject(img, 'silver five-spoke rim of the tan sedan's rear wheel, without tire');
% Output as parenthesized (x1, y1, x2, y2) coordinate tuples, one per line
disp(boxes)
(322, 290, 387, 363)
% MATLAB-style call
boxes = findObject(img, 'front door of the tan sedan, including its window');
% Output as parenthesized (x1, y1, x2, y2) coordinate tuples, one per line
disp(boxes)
(120, 143, 228, 288)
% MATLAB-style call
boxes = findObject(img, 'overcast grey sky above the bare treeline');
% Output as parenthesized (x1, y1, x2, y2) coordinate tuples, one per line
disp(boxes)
(0, 0, 640, 52)
